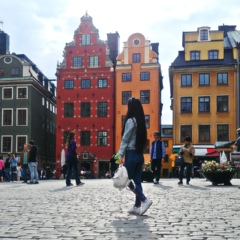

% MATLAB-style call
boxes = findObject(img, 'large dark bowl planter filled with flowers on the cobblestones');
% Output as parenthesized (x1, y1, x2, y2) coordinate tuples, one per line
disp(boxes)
(201, 161, 237, 185)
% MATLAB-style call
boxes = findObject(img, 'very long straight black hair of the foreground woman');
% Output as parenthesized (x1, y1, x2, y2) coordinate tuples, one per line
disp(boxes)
(122, 97, 147, 153)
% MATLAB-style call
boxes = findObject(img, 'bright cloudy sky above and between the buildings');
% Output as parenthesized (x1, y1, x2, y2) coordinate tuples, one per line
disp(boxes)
(0, 0, 240, 123)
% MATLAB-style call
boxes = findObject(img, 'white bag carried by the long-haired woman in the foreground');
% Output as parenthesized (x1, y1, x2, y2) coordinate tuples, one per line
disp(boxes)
(112, 164, 129, 191)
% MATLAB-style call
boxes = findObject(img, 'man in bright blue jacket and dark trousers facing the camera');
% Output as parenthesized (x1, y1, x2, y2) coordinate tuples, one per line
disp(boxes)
(150, 132, 166, 184)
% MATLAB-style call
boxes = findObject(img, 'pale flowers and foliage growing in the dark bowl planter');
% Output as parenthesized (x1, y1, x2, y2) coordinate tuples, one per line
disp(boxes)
(202, 160, 234, 173)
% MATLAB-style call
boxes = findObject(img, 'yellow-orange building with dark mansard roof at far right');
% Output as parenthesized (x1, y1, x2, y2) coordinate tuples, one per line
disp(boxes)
(169, 25, 239, 145)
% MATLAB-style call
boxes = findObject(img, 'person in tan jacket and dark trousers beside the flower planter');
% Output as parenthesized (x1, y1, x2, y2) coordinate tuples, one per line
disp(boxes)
(178, 136, 195, 185)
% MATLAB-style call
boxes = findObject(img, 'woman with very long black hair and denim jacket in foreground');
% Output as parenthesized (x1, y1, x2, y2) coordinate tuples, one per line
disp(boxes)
(118, 97, 152, 215)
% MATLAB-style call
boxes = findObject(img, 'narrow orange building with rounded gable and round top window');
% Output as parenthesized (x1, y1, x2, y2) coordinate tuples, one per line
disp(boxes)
(115, 33, 162, 162)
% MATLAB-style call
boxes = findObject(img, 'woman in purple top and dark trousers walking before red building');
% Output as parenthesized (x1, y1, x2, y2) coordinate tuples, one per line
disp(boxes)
(65, 132, 84, 187)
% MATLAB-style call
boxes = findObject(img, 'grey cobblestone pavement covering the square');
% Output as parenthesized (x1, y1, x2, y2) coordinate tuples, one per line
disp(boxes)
(0, 179, 240, 240)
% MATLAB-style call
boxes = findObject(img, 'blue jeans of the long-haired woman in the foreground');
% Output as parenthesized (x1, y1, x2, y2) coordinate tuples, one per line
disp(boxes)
(124, 150, 146, 207)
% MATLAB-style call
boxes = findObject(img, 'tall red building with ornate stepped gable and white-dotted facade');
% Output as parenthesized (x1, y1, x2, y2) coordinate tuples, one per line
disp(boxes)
(56, 13, 119, 177)
